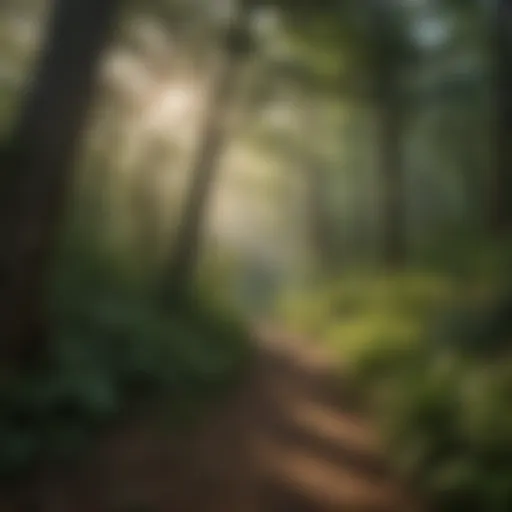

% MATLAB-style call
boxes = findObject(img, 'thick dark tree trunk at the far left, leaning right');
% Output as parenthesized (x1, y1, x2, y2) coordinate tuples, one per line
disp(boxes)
(0, 0, 119, 360)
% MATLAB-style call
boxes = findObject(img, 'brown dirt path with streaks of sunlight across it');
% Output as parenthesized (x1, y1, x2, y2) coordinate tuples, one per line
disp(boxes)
(0, 329, 419, 512)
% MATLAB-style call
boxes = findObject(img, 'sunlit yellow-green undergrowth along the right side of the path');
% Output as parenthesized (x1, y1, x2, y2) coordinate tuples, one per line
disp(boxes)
(281, 245, 512, 511)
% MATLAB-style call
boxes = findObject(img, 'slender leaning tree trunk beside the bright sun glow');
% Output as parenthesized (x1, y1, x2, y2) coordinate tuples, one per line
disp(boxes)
(164, 0, 250, 295)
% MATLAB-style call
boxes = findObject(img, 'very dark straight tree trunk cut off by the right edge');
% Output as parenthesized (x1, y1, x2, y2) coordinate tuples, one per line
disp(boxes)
(490, 0, 512, 235)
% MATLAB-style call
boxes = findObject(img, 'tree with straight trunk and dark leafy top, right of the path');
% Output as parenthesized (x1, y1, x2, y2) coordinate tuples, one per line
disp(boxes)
(272, 0, 416, 267)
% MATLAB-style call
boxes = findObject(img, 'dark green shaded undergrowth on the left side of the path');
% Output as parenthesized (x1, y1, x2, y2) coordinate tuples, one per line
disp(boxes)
(0, 224, 249, 478)
